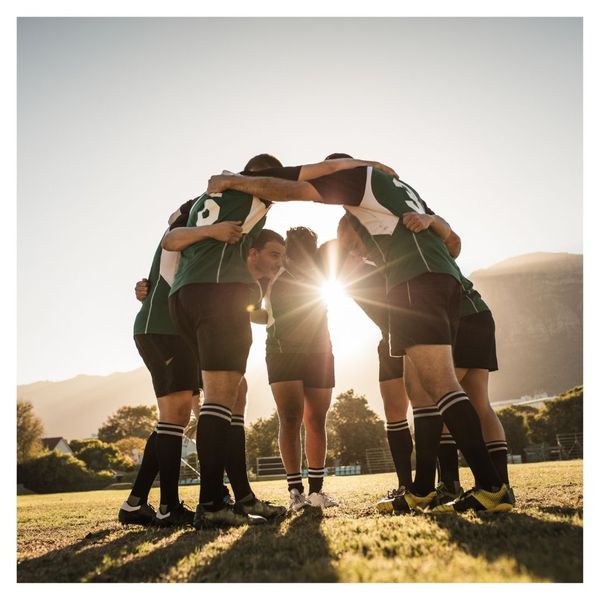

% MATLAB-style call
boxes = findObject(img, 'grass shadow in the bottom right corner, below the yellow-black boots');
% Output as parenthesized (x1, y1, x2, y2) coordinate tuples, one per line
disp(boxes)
(431, 509, 583, 583)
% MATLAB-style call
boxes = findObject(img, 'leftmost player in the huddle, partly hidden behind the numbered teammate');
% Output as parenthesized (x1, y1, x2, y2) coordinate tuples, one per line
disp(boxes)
(118, 203, 242, 526)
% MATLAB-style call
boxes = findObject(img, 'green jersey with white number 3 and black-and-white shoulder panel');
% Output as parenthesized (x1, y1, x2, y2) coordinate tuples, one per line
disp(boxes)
(310, 167, 460, 290)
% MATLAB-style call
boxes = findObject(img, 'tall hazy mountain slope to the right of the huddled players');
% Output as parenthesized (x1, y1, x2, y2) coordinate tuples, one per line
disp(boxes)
(470, 253, 583, 400)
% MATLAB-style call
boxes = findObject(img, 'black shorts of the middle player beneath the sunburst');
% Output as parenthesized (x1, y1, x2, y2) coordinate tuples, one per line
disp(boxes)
(267, 352, 335, 389)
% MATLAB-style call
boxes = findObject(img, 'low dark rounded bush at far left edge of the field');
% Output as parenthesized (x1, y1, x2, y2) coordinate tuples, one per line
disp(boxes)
(19, 452, 113, 494)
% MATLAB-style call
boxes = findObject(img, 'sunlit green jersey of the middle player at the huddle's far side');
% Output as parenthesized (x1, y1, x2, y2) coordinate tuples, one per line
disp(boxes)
(265, 270, 331, 354)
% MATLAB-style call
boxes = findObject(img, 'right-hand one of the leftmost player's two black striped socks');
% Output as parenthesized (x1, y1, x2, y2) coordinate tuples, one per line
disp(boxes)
(156, 421, 184, 507)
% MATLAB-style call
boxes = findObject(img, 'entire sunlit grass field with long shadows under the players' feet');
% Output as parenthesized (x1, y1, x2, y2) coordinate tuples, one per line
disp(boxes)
(17, 461, 583, 582)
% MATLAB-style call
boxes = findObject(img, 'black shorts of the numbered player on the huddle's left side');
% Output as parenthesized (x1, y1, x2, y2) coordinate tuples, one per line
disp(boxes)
(169, 283, 252, 374)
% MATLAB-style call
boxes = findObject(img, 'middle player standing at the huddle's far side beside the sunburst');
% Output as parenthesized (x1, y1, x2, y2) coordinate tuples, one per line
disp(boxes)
(265, 227, 337, 511)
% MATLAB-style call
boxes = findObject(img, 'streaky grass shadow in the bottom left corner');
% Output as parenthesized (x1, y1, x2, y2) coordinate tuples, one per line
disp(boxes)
(17, 527, 214, 583)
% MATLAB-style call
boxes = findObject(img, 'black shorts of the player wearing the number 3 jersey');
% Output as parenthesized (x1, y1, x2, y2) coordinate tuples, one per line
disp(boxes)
(387, 273, 462, 356)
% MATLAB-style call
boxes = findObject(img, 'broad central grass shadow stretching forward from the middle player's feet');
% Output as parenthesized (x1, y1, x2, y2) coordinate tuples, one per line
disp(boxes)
(188, 509, 338, 583)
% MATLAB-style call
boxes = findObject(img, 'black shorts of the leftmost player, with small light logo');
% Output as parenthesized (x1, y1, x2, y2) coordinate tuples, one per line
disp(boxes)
(133, 333, 201, 398)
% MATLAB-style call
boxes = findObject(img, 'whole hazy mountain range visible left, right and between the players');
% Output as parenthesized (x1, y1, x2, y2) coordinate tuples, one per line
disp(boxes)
(17, 253, 583, 440)
